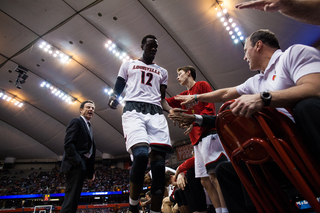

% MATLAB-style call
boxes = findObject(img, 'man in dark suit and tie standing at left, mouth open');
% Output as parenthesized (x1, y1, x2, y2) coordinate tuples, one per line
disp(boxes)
(60, 100, 96, 213)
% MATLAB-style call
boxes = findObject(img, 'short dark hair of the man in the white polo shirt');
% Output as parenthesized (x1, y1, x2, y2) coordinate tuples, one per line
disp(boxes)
(247, 29, 280, 49)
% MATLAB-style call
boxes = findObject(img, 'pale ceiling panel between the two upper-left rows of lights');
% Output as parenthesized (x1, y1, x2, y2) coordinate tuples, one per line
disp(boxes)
(44, 15, 122, 86)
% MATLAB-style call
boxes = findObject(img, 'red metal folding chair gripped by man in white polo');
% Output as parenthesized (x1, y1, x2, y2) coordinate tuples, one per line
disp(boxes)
(216, 100, 320, 213)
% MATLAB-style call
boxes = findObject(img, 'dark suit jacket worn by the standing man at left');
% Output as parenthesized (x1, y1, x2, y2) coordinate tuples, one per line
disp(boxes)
(60, 117, 96, 179)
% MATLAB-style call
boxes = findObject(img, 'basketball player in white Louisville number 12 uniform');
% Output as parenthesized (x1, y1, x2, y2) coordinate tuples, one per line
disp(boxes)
(109, 35, 173, 213)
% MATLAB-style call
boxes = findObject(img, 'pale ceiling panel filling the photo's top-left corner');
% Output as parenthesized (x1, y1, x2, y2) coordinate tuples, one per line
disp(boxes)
(0, 0, 75, 35)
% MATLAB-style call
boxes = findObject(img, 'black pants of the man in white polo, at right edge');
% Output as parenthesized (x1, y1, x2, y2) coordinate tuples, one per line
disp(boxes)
(293, 98, 320, 163)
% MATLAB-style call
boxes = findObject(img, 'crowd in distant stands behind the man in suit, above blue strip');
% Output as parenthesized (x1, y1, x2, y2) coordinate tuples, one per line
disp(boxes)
(0, 166, 129, 196)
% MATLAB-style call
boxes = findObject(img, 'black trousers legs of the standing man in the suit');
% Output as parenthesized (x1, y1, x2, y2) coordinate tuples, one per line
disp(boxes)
(60, 165, 86, 213)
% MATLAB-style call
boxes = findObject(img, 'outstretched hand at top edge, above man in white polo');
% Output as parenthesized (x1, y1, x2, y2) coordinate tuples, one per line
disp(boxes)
(235, 0, 282, 12)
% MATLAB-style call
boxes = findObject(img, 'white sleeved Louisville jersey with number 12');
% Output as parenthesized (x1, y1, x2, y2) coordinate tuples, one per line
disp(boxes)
(118, 59, 168, 107)
